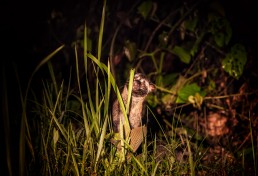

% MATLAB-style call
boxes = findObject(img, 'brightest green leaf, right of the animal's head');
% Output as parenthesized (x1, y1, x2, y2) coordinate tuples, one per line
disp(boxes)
(176, 83, 206, 103)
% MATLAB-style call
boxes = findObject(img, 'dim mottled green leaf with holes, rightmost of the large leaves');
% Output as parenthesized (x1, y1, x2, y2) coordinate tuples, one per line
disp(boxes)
(222, 44, 247, 79)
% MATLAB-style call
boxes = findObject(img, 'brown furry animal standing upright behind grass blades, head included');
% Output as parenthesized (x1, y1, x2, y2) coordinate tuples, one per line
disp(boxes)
(112, 73, 156, 151)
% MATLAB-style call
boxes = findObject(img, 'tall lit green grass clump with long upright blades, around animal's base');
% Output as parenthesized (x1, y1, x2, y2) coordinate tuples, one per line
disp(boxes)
(20, 2, 202, 175)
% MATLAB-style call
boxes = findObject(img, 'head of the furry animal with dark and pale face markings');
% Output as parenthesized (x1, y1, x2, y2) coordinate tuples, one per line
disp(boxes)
(127, 73, 156, 97)
